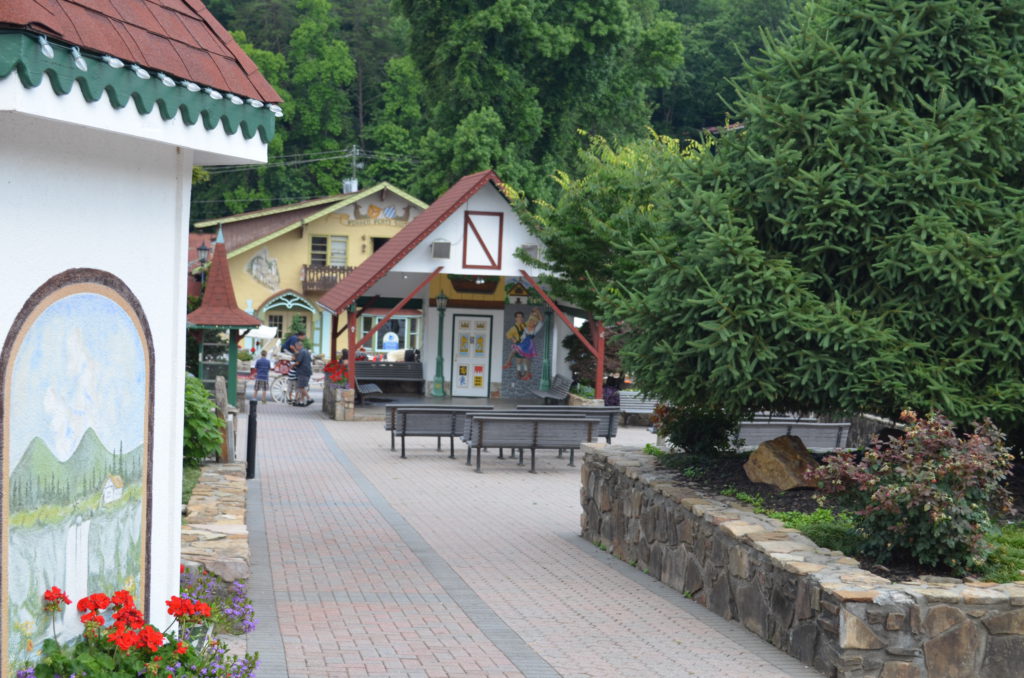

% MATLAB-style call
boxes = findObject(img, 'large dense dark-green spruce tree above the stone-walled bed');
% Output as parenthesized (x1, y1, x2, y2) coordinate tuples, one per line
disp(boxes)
(539, 0, 1024, 432)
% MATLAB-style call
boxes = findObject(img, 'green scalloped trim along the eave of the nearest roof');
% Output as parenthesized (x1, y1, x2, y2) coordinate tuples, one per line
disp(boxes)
(0, 32, 275, 143)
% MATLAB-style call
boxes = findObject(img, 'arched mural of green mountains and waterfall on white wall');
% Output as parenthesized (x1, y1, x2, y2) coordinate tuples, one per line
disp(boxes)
(0, 269, 153, 675)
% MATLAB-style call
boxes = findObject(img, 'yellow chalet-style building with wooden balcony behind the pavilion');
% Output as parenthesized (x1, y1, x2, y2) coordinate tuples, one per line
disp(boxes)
(194, 182, 426, 355)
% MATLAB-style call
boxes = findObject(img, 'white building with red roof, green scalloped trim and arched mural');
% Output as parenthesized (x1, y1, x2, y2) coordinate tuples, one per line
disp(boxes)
(0, 0, 281, 675)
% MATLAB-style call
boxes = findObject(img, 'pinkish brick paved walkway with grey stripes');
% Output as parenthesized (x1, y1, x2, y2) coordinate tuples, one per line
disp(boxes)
(237, 406, 819, 678)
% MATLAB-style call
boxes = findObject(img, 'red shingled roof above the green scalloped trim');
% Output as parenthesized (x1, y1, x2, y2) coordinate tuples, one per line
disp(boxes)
(0, 0, 281, 101)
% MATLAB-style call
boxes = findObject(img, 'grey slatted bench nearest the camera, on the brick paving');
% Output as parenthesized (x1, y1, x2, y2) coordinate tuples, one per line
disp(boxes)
(467, 415, 597, 473)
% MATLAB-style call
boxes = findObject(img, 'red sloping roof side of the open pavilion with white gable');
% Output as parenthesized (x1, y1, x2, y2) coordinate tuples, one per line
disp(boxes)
(318, 170, 502, 313)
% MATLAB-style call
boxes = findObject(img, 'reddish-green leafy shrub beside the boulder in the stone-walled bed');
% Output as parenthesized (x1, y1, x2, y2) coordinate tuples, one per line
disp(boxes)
(808, 412, 1013, 575)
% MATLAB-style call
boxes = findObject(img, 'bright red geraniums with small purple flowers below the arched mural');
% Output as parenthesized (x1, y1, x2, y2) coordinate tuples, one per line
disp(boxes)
(17, 587, 258, 678)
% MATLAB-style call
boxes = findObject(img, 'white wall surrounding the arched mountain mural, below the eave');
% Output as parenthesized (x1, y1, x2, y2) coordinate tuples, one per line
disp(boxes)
(0, 110, 193, 628)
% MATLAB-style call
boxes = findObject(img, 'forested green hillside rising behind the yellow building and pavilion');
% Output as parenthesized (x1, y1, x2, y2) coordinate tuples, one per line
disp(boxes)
(193, 0, 796, 220)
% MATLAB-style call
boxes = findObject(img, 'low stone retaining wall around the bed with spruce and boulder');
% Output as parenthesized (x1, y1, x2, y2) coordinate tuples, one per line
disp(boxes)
(581, 446, 1024, 678)
